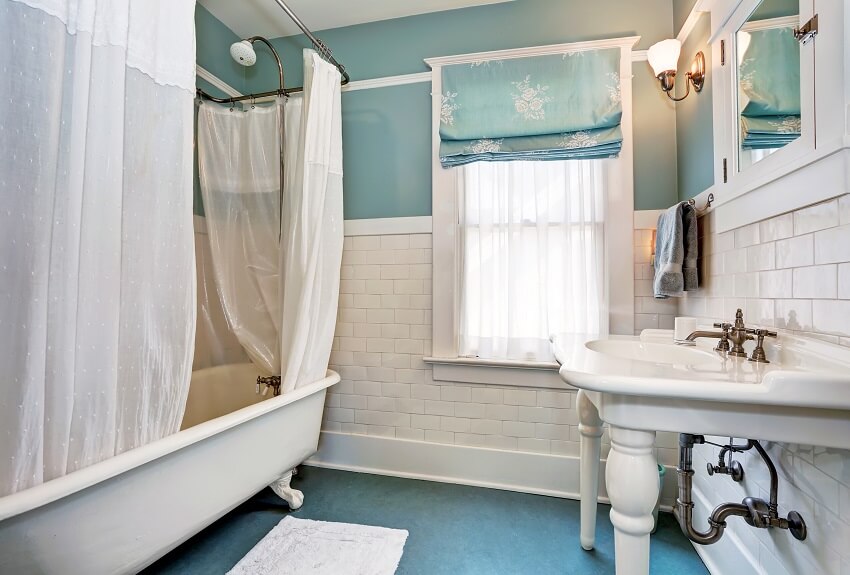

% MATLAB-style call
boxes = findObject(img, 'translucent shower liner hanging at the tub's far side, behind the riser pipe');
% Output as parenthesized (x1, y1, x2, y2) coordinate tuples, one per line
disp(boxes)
(198, 99, 295, 374)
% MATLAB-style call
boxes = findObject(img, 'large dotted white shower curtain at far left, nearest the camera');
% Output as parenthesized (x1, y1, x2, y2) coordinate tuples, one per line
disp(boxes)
(0, 0, 195, 496)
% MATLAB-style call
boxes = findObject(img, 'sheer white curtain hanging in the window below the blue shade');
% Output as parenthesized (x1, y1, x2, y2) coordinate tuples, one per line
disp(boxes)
(458, 160, 608, 361)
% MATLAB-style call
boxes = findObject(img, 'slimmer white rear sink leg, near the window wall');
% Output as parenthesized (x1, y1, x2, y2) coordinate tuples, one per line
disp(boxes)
(576, 390, 602, 551)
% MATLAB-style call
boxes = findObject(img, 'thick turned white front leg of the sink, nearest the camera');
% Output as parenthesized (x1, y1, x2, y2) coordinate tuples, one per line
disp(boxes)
(605, 426, 658, 575)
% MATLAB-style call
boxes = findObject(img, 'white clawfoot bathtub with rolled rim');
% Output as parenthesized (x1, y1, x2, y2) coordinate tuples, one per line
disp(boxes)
(0, 364, 339, 575)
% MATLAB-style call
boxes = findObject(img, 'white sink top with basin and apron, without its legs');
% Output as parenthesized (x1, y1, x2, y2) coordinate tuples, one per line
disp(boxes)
(552, 330, 850, 449)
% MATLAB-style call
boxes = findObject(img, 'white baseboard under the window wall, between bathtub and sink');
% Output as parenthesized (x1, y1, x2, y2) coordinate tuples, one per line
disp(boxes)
(304, 431, 608, 503)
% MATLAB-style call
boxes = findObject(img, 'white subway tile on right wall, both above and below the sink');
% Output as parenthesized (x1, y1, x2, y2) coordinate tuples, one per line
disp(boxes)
(676, 195, 850, 575)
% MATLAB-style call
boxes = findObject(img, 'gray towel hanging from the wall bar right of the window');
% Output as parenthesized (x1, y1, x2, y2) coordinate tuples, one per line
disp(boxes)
(653, 202, 698, 299)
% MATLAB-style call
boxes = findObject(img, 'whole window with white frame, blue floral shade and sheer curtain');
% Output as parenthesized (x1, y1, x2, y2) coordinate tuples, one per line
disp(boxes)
(427, 38, 636, 378)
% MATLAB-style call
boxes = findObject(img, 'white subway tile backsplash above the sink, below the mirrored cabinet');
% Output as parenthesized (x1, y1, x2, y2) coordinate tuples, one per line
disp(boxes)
(679, 195, 850, 345)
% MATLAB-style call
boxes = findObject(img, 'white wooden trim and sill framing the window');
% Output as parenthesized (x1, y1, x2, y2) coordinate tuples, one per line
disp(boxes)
(425, 36, 640, 387)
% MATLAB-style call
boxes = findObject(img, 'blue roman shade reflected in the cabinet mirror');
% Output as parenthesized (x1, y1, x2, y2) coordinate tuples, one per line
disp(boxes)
(738, 27, 801, 150)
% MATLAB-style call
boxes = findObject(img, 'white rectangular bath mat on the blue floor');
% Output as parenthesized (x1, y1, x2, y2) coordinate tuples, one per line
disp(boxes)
(228, 516, 407, 575)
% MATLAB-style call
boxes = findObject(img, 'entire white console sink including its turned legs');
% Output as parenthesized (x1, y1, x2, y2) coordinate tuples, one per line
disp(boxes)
(552, 330, 850, 575)
